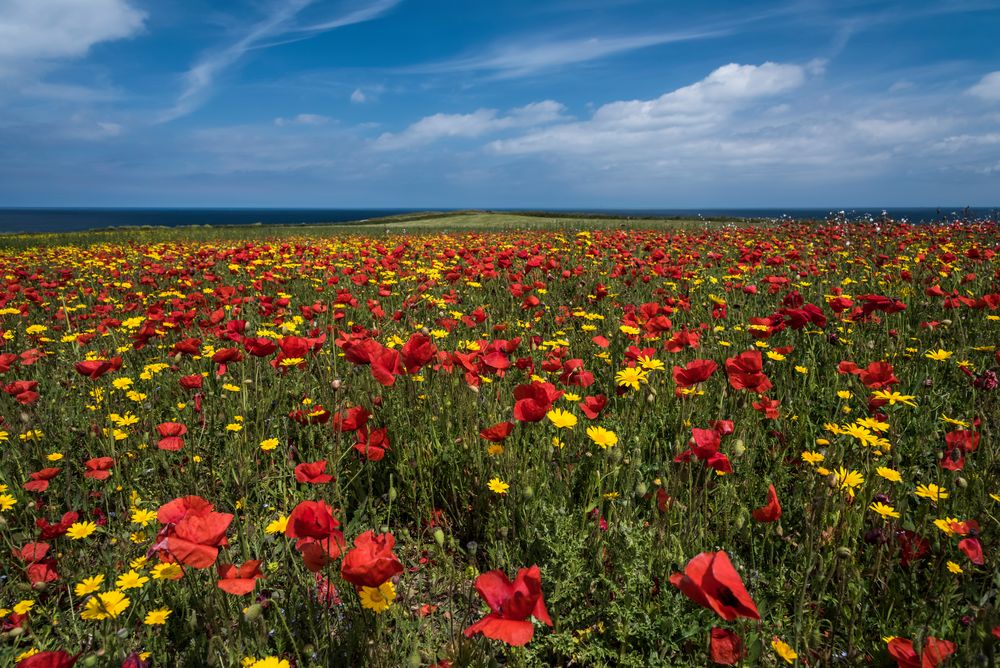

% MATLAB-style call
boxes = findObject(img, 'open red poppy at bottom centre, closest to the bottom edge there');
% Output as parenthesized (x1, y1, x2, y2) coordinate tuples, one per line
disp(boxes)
(464, 566, 552, 647)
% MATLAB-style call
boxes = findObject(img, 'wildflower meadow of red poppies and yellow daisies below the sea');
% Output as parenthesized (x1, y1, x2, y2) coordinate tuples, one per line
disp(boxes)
(0, 213, 1000, 668)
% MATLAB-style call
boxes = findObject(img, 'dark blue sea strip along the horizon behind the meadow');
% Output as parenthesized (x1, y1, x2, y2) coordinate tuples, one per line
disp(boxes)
(0, 207, 1000, 233)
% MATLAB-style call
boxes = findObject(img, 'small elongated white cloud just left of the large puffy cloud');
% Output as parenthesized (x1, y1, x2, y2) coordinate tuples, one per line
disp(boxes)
(375, 100, 565, 150)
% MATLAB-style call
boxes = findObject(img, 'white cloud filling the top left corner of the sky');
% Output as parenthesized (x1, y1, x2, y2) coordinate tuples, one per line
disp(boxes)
(0, 0, 146, 76)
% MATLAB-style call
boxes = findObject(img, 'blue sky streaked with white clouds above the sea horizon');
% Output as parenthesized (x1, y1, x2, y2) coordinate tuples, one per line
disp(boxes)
(0, 0, 1000, 208)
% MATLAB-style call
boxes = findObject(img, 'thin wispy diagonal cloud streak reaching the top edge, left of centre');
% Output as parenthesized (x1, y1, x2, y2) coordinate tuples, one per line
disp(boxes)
(156, 0, 401, 123)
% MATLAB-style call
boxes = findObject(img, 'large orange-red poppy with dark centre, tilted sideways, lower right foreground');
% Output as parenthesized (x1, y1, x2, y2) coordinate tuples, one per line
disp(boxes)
(670, 550, 760, 622)
